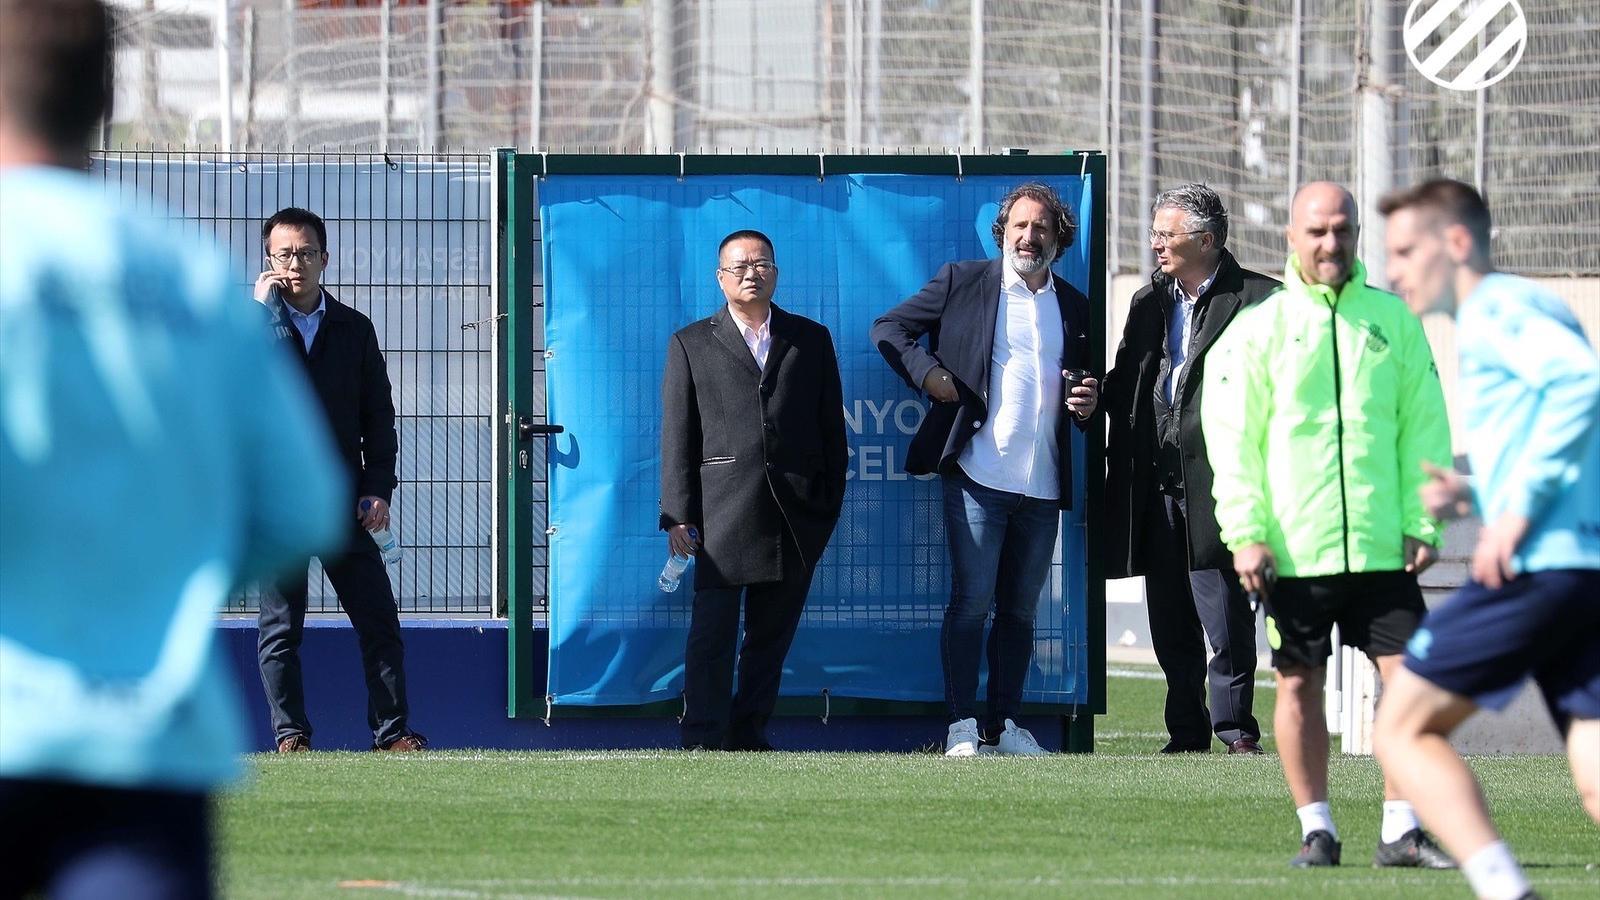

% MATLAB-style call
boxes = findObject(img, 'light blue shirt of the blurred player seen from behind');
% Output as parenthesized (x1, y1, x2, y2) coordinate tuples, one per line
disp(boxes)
(0, 168, 346, 790)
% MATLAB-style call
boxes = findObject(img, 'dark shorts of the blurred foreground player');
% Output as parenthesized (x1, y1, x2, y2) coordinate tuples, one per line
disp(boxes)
(0, 778, 214, 900)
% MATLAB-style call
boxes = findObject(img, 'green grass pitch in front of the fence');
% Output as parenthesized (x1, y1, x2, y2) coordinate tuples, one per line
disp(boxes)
(221, 666, 1600, 898)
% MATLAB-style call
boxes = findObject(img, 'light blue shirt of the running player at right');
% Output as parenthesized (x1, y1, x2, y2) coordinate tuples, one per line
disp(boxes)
(1456, 272, 1600, 572)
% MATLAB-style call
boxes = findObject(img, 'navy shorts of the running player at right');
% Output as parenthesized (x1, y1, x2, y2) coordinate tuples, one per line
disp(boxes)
(1405, 569, 1600, 730)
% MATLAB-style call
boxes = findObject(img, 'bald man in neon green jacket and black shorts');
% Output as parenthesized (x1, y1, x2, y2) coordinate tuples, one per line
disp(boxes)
(1200, 181, 1454, 868)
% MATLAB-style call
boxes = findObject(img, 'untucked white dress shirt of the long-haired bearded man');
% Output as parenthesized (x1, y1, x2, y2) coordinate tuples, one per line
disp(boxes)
(958, 266, 1064, 500)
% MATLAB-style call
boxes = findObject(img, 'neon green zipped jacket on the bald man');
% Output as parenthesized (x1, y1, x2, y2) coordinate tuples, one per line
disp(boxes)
(1200, 255, 1451, 578)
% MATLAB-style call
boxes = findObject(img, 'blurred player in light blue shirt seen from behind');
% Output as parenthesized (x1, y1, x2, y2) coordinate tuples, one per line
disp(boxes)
(0, 0, 347, 897)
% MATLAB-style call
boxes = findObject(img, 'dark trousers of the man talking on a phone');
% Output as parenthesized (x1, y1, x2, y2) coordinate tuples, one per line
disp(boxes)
(256, 532, 410, 746)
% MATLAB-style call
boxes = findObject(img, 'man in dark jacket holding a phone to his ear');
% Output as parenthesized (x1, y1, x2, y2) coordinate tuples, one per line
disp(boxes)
(254, 207, 427, 753)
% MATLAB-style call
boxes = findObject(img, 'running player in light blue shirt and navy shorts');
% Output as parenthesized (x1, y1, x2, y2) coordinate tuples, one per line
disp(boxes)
(1376, 179, 1600, 900)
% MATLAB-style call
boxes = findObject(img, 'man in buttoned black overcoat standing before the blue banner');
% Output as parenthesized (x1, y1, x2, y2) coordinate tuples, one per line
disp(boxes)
(661, 231, 848, 751)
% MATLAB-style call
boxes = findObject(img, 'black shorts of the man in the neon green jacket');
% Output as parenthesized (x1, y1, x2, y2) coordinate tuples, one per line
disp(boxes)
(1267, 570, 1427, 669)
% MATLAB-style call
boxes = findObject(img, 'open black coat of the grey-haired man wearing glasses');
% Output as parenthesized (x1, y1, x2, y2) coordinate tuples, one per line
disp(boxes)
(1101, 250, 1278, 578)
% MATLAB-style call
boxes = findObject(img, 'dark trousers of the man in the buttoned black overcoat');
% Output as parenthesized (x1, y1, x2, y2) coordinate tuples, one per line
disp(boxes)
(682, 528, 813, 749)
